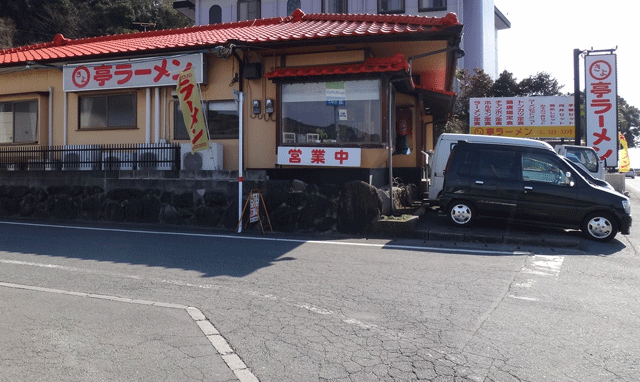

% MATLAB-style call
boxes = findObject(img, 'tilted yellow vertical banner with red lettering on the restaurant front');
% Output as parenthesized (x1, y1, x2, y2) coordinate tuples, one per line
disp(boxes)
(176, 69, 209, 153)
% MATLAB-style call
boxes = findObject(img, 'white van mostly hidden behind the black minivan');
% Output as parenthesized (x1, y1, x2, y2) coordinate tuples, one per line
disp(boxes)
(428, 133, 553, 203)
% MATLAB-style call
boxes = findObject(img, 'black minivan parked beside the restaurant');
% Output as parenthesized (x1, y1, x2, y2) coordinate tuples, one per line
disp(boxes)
(440, 141, 631, 242)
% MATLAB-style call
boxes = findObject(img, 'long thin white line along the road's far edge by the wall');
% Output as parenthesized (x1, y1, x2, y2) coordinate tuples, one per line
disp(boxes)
(0, 221, 531, 256)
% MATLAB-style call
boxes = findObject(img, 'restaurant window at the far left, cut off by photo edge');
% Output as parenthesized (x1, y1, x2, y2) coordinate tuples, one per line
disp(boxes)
(0, 100, 38, 143)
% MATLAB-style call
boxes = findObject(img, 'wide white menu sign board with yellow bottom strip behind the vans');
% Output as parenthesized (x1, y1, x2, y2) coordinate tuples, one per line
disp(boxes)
(469, 96, 575, 138)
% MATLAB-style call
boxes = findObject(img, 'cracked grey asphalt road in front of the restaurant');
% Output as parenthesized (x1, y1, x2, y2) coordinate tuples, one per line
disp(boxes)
(0, 179, 640, 381)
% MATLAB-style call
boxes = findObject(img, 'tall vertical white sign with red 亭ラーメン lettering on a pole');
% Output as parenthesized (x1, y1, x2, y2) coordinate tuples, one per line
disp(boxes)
(584, 54, 618, 167)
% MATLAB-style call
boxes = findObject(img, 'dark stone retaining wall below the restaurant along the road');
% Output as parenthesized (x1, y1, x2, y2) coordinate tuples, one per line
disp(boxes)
(0, 180, 382, 233)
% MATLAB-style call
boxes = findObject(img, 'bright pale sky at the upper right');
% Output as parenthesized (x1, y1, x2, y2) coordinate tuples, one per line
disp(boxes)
(494, 0, 640, 108)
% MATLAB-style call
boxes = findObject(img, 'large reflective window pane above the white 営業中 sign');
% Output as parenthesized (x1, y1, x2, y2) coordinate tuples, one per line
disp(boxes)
(281, 80, 382, 145)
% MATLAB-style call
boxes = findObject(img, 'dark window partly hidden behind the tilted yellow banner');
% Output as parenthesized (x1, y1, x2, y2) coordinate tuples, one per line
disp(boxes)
(173, 101, 240, 140)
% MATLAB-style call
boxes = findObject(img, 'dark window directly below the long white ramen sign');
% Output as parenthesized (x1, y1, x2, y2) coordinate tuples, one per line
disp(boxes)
(79, 93, 137, 129)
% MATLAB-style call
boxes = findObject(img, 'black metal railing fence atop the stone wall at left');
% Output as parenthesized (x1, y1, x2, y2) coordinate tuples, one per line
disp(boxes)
(0, 143, 180, 171)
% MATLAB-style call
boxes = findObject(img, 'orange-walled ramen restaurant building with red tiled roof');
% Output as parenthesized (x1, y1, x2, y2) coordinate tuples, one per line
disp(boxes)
(0, 10, 463, 190)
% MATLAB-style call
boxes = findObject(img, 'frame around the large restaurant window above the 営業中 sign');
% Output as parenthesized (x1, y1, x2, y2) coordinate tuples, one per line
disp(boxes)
(276, 76, 389, 148)
